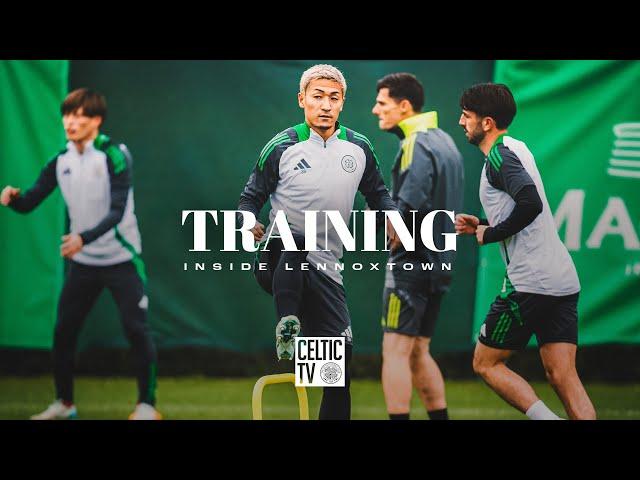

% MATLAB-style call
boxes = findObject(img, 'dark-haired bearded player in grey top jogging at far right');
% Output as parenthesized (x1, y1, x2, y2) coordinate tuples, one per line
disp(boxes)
(456, 83, 595, 419)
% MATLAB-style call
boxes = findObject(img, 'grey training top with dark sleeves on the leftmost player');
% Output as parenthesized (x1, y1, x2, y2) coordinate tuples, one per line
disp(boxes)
(9, 135, 142, 266)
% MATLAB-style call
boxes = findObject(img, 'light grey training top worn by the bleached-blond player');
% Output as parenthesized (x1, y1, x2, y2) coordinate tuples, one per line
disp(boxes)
(238, 123, 396, 284)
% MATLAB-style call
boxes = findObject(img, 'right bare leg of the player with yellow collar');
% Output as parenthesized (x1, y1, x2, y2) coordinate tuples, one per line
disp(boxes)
(411, 337, 447, 411)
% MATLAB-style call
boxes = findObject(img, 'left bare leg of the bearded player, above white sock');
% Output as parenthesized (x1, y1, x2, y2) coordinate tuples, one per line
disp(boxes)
(473, 342, 538, 413)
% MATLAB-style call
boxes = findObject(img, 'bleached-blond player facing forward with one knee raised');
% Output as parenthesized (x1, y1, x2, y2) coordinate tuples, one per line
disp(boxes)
(238, 65, 396, 419)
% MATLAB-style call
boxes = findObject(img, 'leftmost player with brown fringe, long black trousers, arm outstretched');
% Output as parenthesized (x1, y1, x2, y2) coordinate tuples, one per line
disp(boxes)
(0, 88, 160, 420)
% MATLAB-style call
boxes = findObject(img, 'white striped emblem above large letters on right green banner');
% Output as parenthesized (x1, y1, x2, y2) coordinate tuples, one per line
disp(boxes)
(607, 122, 640, 178)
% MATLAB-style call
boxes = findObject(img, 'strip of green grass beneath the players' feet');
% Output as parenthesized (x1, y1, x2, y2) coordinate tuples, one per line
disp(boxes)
(0, 377, 640, 420)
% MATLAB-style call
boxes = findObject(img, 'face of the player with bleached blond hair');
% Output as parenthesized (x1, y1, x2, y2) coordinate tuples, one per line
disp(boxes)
(298, 79, 344, 130)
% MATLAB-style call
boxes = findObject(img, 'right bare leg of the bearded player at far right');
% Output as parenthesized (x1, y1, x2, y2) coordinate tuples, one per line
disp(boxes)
(540, 343, 596, 420)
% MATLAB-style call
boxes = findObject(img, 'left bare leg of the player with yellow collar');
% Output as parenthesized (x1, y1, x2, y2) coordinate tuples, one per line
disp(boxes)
(382, 332, 415, 414)
